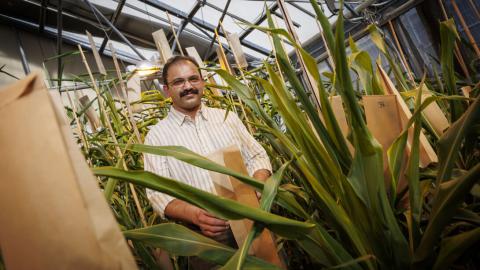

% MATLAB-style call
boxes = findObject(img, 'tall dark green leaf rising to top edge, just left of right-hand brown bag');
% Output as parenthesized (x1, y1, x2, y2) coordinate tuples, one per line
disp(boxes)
(335, 1, 409, 269)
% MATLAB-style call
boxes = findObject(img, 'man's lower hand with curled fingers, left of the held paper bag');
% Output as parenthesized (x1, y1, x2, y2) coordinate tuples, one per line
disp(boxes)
(192, 208, 230, 237)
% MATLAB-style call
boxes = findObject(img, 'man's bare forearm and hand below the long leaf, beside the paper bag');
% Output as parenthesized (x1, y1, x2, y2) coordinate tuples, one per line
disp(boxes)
(164, 199, 229, 237)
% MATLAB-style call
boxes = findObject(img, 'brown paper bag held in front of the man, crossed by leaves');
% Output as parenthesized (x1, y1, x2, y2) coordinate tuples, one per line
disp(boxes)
(208, 146, 285, 268)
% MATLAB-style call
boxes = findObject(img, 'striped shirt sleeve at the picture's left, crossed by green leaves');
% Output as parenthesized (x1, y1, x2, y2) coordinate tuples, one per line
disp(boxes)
(143, 129, 175, 218)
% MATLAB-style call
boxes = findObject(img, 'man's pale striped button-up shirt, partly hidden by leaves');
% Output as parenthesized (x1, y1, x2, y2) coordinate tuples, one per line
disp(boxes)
(144, 105, 272, 217)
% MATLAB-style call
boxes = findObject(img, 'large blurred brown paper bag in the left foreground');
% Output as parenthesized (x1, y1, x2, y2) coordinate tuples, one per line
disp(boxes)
(0, 74, 137, 269)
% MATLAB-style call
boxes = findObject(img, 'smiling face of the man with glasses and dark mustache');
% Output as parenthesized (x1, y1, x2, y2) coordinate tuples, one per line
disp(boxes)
(164, 61, 205, 112)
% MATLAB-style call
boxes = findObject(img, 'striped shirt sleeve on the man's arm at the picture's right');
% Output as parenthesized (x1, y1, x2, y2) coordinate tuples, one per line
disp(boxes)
(229, 113, 272, 176)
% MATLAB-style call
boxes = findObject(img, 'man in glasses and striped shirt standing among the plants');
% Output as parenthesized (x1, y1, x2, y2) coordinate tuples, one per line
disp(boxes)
(144, 56, 271, 249)
